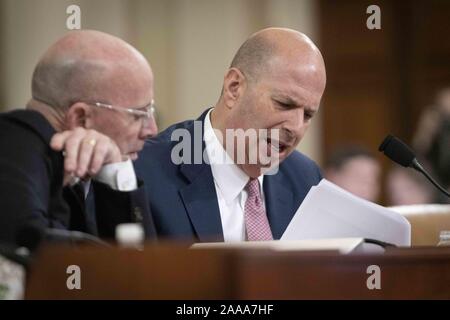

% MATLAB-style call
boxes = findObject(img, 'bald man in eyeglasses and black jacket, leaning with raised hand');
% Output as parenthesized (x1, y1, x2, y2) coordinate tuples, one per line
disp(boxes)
(0, 30, 157, 248)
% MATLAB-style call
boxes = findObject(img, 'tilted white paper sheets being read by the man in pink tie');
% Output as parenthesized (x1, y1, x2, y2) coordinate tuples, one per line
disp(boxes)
(280, 179, 411, 246)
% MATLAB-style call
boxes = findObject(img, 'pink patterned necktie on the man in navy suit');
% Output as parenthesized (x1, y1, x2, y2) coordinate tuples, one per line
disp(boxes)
(244, 179, 273, 241)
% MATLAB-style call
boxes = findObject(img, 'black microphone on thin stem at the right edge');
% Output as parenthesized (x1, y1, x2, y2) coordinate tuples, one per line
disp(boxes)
(378, 135, 450, 197)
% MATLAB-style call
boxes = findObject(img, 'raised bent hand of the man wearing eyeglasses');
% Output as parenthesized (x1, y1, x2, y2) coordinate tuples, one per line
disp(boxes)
(50, 127, 123, 182)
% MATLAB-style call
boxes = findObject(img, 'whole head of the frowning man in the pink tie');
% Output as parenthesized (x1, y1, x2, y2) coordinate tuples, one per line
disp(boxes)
(210, 28, 326, 178)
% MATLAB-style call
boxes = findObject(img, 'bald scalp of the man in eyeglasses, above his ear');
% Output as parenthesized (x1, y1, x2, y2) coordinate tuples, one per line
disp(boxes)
(32, 30, 153, 111)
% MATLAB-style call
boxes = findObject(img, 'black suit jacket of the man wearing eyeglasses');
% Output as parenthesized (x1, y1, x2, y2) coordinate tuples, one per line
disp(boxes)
(0, 110, 155, 243)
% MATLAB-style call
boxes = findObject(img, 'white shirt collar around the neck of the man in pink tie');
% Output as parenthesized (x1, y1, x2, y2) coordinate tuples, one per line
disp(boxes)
(204, 109, 263, 204)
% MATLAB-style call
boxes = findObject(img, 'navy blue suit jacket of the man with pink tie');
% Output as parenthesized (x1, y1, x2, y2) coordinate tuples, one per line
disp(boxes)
(135, 111, 322, 241)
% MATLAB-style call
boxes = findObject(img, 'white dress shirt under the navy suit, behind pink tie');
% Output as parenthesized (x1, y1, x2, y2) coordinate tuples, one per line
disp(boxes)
(203, 109, 265, 242)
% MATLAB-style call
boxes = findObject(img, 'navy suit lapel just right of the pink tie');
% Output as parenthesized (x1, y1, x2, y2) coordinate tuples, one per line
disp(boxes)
(263, 171, 296, 239)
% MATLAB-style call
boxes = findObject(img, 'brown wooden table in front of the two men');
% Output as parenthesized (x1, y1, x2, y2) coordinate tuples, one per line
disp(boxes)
(26, 244, 450, 299)
